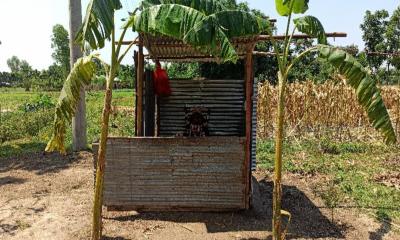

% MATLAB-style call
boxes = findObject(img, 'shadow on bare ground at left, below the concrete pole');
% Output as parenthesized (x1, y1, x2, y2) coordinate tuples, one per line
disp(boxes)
(0, 143, 88, 174)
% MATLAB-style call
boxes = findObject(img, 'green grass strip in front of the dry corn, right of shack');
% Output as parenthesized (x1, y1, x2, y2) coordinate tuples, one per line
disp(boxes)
(257, 139, 400, 222)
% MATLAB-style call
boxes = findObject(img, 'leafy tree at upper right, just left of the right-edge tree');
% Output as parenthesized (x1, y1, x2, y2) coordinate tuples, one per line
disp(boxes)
(360, 10, 389, 74)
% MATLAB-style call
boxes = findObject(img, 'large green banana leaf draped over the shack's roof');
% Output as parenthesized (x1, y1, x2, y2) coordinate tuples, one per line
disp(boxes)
(134, 4, 270, 62)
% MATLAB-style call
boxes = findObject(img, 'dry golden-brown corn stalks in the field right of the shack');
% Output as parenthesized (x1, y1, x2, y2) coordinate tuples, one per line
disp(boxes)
(258, 81, 400, 140)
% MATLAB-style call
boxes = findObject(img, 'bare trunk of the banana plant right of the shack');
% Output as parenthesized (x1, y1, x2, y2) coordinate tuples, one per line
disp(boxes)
(272, 72, 287, 240)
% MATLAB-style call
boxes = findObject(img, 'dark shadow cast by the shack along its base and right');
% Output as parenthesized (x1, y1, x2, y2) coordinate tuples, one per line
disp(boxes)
(108, 177, 347, 240)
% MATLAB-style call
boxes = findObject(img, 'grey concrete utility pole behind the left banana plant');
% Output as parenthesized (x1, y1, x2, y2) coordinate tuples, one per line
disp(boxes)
(69, 0, 87, 151)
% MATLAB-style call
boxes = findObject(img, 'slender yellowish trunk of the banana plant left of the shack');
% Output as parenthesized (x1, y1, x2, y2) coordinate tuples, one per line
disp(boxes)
(92, 71, 115, 240)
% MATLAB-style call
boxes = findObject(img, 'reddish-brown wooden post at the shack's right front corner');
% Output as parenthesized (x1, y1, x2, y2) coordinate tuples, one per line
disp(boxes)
(244, 50, 254, 209)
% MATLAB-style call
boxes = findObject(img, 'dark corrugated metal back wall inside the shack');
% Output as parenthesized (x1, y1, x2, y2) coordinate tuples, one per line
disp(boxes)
(159, 79, 245, 136)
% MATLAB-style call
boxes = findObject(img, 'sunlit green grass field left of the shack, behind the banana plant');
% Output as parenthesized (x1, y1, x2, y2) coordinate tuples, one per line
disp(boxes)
(0, 89, 134, 157)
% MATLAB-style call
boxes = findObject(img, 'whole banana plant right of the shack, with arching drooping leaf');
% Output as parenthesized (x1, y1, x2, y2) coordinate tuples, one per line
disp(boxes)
(270, 0, 397, 240)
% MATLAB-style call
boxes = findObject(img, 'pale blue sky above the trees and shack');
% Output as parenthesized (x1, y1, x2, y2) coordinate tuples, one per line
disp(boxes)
(0, 0, 399, 71)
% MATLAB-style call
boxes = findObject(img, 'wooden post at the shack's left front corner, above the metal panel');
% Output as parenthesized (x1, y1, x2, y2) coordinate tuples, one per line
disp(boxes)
(136, 36, 144, 137)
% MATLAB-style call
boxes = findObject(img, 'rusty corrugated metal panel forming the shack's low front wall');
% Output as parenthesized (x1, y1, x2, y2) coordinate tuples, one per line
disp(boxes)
(97, 137, 245, 211)
